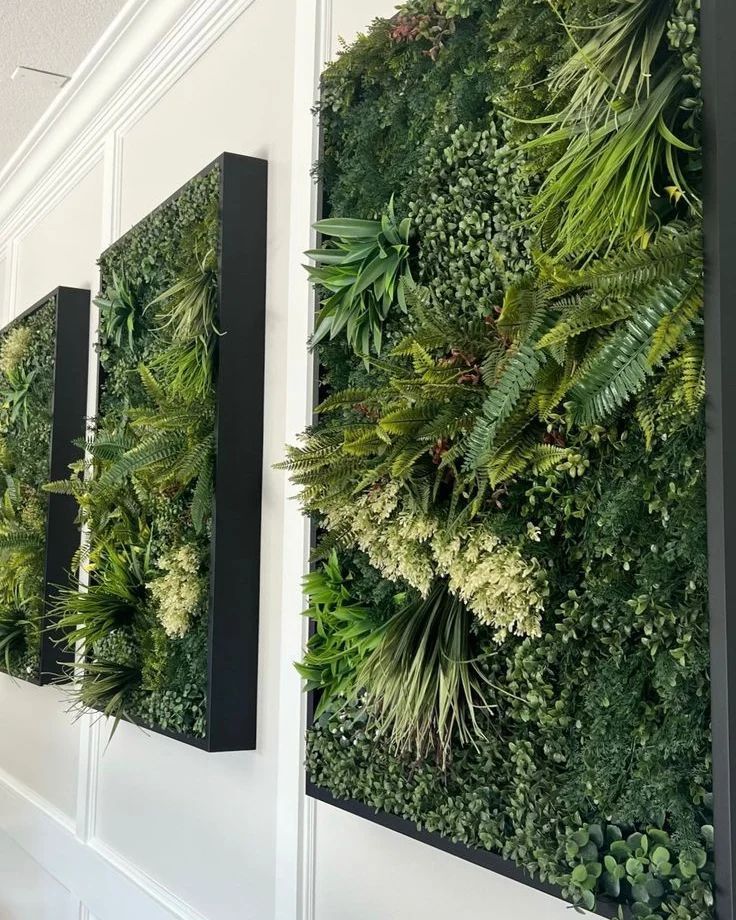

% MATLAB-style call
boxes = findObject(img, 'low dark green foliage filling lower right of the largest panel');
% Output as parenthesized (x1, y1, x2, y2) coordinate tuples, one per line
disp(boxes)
(309, 426, 710, 916)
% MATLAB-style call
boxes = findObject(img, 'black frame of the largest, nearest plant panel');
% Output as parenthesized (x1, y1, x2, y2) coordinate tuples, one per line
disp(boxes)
(305, 0, 724, 920)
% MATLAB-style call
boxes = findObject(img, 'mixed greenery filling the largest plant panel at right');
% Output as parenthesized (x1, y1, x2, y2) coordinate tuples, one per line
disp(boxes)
(284, 0, 713, 920)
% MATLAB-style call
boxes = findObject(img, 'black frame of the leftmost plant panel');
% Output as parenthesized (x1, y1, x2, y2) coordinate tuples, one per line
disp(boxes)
(2, 287, 90, 685)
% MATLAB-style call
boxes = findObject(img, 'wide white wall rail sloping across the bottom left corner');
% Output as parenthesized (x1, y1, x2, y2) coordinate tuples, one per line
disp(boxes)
(0, 771, 206, 920)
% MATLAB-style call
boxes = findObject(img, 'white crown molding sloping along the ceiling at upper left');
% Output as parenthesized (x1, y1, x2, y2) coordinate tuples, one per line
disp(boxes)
(0, 0, 254, 250)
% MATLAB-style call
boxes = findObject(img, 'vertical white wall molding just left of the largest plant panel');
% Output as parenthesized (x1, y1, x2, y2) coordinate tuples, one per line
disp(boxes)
(275, 0, 333, 920)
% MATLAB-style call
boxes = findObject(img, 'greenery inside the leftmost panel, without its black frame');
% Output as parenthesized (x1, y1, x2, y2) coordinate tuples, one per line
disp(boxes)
(0, 300, 56, 682)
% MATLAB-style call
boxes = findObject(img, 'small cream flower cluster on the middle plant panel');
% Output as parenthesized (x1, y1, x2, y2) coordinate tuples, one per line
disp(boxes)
(147, 546, 203, 638)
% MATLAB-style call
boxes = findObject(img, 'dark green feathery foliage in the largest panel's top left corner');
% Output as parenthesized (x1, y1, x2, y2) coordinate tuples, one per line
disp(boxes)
(319, 17, 492, 217)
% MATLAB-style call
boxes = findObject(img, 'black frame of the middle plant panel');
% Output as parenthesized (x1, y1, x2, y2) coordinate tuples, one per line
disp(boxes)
(98, 153, 268, 752)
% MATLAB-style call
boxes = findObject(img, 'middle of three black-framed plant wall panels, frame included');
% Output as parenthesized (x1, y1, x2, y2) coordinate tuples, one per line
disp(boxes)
(50, 154, 267, 751)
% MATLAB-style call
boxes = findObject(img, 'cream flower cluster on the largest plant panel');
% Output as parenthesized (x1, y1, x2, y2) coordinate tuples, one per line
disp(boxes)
(326, 482, 549, 641)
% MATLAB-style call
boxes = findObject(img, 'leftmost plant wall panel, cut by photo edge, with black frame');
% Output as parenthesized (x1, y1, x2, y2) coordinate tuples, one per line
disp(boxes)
(0, 287, 89, 684)
